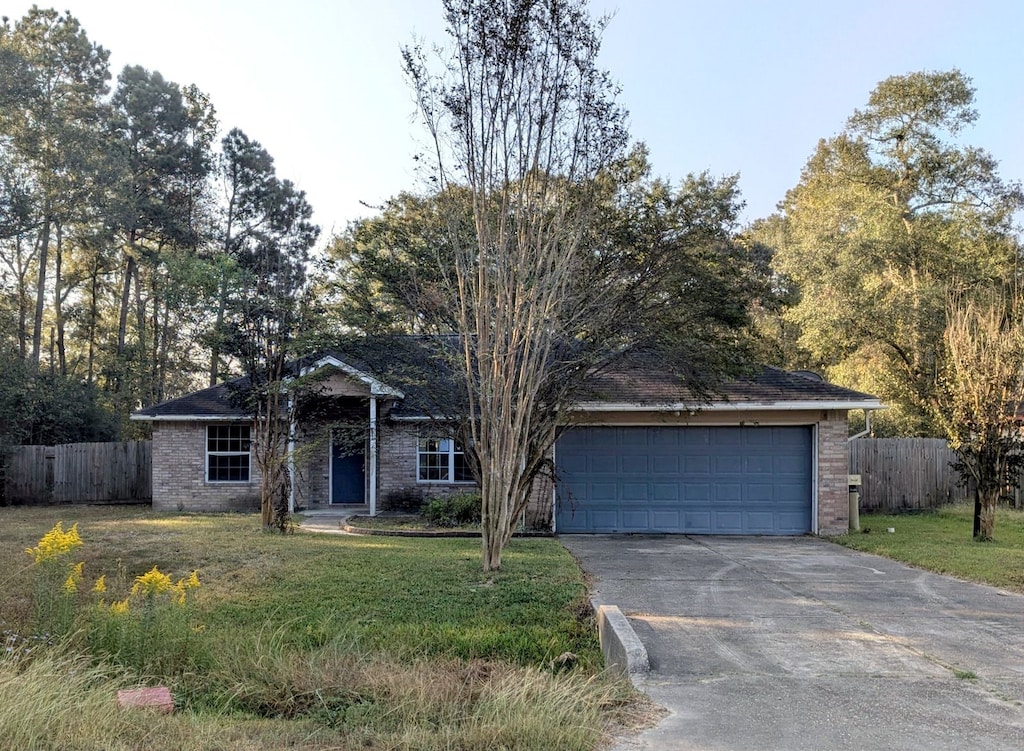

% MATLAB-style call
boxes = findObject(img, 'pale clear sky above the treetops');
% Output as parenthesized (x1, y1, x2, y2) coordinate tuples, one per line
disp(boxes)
(8, 0, 1024, 236)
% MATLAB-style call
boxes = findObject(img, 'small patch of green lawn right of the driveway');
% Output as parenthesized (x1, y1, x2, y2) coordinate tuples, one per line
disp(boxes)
(833, 505, 1024, 592)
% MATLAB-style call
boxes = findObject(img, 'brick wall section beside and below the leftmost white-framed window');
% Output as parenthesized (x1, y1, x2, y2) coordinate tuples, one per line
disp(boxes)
(153, 421, 260, 511)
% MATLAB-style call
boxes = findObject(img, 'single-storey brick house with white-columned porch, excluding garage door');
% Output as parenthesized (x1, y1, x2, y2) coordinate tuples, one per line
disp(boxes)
(133, 342, 882, 534)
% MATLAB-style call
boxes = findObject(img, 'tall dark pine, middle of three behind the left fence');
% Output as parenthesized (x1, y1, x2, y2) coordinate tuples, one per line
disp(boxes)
(108, 66, 216, 405)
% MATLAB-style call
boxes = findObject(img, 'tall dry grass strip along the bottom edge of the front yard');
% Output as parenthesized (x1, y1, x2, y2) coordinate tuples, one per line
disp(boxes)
(0, 645, 630, 751)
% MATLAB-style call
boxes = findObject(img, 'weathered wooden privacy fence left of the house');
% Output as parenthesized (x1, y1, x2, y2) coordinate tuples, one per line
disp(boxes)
(3, 441, 153, 503)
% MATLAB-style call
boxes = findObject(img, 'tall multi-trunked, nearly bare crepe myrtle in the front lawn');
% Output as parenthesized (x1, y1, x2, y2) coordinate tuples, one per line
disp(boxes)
(403, 0, 628, 571)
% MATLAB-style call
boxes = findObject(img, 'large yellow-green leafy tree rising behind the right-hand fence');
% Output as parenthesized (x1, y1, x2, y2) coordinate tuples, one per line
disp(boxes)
(770, 70, 1022, 434)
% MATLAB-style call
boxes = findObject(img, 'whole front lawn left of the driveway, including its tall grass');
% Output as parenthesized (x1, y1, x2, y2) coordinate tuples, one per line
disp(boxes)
(0, 506, 633, 751)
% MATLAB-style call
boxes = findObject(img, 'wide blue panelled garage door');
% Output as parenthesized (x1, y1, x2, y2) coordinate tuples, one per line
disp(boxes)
(555, 426, 812, 535)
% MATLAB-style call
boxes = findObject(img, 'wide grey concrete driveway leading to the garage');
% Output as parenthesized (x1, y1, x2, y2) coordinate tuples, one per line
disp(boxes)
(561, 536, 1024, 751)
